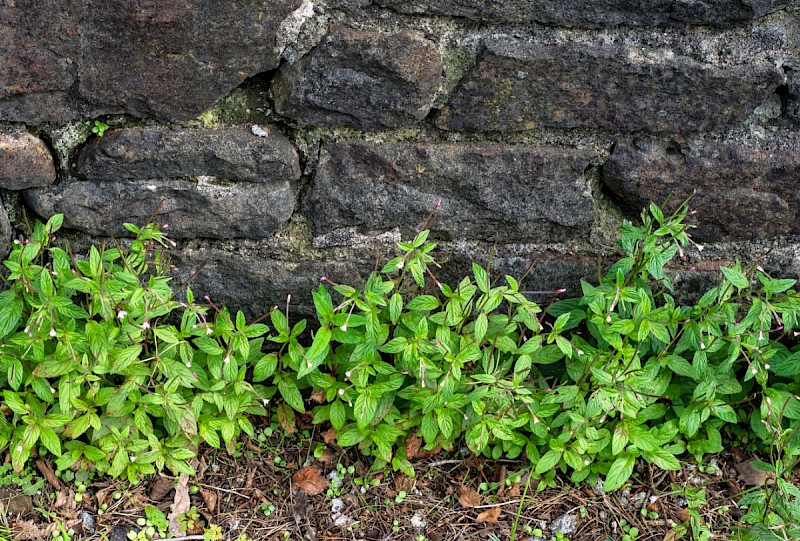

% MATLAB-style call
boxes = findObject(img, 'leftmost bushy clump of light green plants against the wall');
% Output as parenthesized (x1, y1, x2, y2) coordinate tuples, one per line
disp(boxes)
(0, 215, 274, 482)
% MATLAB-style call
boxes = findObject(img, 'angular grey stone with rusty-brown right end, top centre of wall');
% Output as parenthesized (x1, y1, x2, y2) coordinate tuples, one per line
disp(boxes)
(272, 27, 444, 130)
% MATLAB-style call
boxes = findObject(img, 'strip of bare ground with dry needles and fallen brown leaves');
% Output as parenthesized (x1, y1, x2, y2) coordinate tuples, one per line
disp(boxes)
(0, 418, 764, 541)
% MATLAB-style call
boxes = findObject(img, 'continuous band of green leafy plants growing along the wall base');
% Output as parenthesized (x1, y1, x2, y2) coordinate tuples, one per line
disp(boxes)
(0, 204, 800, 520)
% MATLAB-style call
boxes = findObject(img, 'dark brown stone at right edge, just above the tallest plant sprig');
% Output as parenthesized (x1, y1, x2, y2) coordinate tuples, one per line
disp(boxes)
(603, 135, 800, 241)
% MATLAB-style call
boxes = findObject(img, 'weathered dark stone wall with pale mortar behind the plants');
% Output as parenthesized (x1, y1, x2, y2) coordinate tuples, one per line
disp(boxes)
(0, 0, 800, 314)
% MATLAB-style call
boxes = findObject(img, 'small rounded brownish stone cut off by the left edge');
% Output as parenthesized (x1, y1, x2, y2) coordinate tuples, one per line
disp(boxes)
(0, 130, 56, 190)
